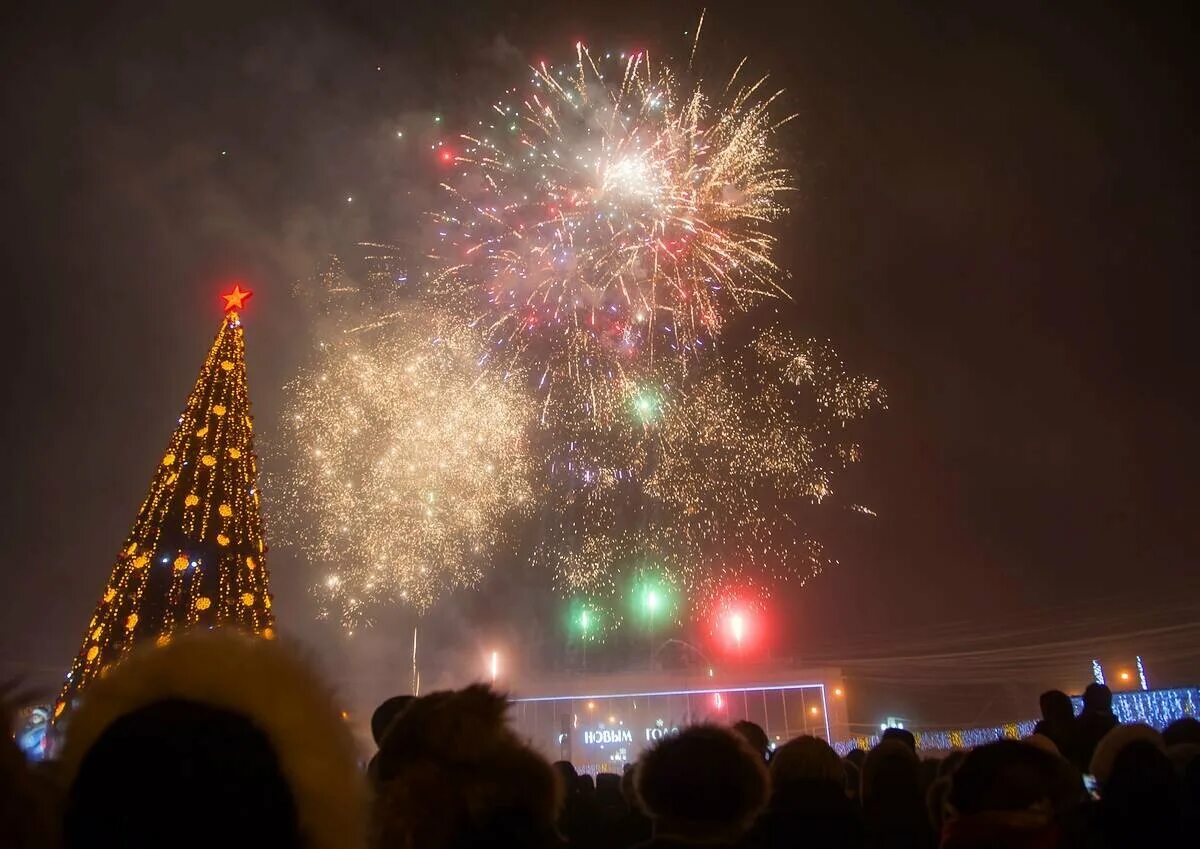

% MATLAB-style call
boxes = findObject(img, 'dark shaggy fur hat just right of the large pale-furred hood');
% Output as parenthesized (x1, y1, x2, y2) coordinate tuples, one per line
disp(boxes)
(376, 685, 562, 849)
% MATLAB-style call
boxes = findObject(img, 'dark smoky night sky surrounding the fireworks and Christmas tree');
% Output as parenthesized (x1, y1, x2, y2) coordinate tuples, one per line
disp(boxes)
(0, 0, 1200, 719)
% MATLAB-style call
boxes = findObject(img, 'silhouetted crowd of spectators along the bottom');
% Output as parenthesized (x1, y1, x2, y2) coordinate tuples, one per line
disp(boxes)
(0, 632, 1200, 849)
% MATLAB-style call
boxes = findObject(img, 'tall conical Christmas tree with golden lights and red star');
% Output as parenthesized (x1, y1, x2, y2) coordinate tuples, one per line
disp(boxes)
(54, 287, 275, 718)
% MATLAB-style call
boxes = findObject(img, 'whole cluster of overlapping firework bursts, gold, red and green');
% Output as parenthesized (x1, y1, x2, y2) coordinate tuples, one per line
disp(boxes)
(274, 26, 884, 645)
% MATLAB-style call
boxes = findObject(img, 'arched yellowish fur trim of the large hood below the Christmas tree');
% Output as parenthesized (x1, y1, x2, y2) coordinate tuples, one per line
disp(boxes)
(60, 631, 367, 849)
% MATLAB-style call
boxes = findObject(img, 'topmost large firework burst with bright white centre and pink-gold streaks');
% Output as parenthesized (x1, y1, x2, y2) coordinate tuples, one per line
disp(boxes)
(434, 44, 788, 422)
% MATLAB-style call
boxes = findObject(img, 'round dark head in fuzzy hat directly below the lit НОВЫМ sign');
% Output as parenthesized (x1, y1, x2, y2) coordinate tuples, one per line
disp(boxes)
(635, 725, 768, 841)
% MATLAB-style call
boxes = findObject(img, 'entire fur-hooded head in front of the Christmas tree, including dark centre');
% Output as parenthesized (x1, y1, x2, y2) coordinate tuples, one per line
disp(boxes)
(60, 631, 366, 849)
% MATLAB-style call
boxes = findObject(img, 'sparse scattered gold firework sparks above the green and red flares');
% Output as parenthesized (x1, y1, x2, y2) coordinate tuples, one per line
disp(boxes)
(534, 330, 884, 609)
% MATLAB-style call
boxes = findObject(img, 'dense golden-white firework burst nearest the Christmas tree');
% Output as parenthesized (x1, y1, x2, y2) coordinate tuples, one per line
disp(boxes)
(280, 309, 533, 628)
